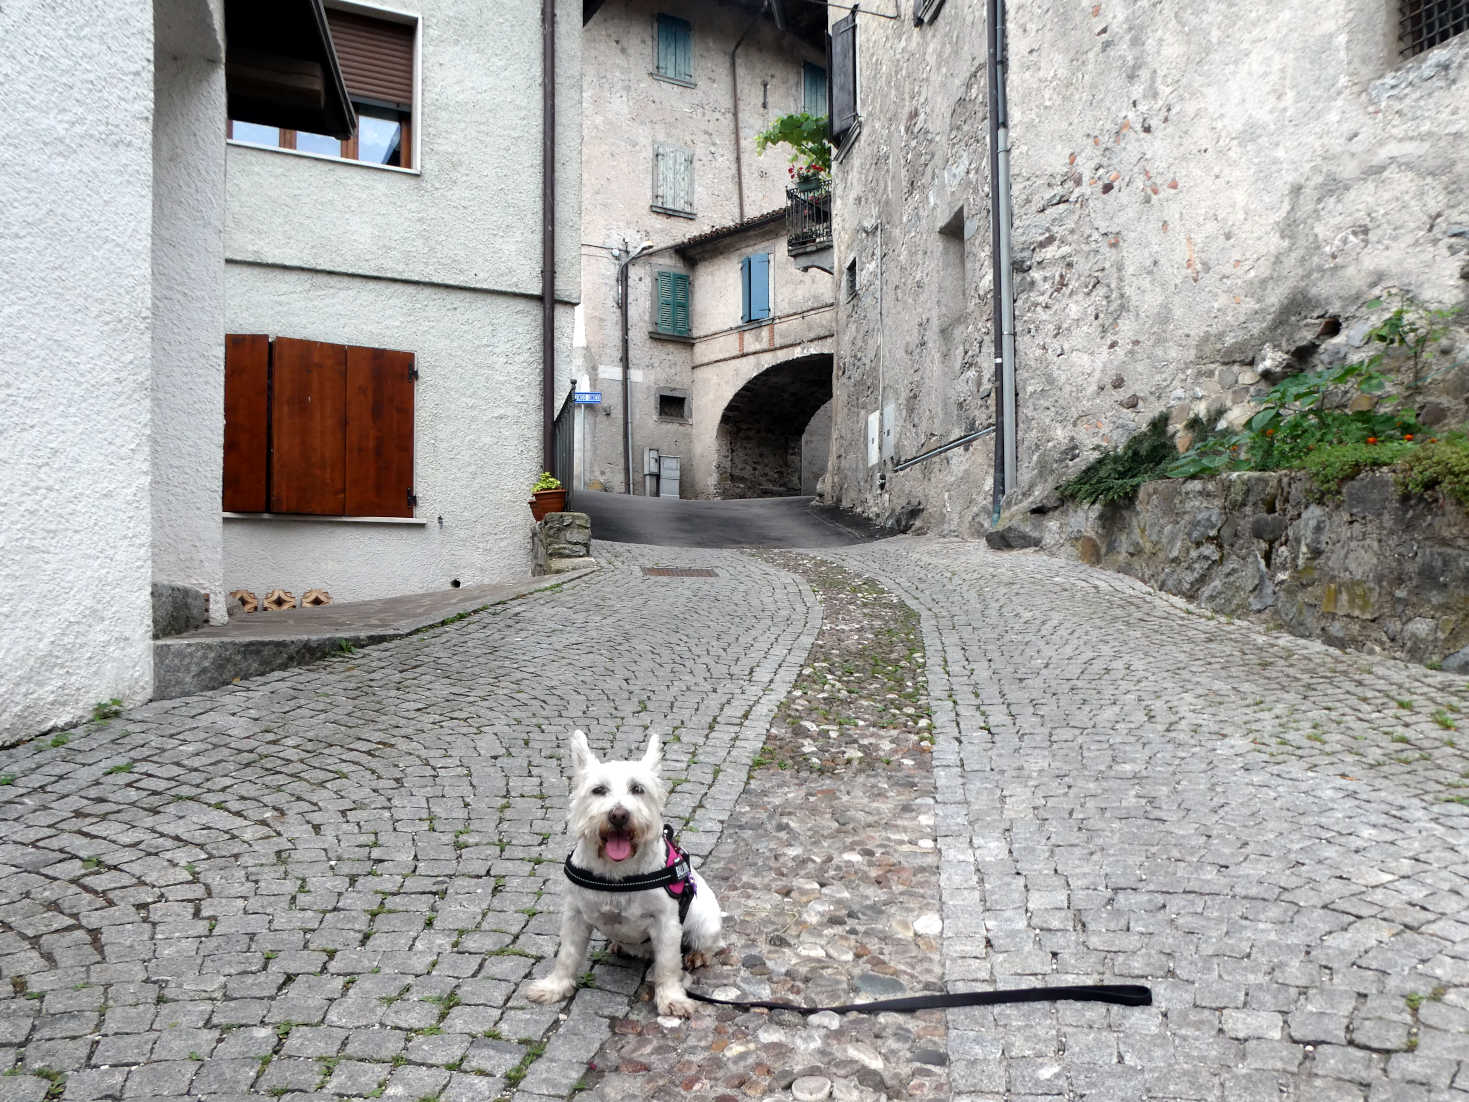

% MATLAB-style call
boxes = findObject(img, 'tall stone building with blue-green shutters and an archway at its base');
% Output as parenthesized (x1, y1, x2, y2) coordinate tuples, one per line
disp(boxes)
(576, 0, 831, 497)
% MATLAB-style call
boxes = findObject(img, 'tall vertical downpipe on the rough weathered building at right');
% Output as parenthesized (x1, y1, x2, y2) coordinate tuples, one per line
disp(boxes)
(986, 0, 1017, 526)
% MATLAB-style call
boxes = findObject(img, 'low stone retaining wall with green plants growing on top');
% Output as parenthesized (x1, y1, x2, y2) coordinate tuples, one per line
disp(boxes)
(1025, 472, 1469, 671)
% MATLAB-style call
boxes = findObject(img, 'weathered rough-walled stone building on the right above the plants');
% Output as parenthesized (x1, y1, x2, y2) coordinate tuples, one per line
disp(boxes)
(830, 0, 1469, 535)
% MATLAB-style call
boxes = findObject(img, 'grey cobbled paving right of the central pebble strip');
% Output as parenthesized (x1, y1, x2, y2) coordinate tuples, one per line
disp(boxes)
(831, 539, 1469, 1102)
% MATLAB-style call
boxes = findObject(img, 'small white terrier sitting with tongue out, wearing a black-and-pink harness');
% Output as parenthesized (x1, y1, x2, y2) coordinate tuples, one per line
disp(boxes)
(527, 730, 721, 1018)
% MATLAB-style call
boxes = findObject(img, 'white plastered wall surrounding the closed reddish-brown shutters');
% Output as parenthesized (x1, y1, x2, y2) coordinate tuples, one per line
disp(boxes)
(223, 0, 580, 601)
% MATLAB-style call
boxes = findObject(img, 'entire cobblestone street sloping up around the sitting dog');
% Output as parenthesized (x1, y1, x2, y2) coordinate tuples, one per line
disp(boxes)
(0, 539, 1469, 1102)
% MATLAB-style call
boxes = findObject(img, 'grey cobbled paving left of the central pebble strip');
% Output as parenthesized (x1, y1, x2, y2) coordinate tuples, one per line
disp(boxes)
(0, 545, 820, 1102)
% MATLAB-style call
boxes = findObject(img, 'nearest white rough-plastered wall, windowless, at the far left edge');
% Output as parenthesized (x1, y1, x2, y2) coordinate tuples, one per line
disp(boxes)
(0, 0, 153, 741)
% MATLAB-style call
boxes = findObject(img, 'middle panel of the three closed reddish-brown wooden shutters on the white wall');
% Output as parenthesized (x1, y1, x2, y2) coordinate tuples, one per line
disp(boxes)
(270, 336, 347, 516)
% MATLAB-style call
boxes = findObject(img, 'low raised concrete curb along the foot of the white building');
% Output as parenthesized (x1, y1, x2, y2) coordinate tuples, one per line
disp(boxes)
(153, 569, 592, 701)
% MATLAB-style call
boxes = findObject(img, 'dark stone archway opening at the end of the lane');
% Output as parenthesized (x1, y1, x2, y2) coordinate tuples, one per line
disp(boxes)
(714, 353, 831, 498)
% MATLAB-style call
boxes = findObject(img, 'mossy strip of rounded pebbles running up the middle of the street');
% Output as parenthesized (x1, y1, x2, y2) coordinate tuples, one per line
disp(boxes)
(588, 552, 950, 1102)
